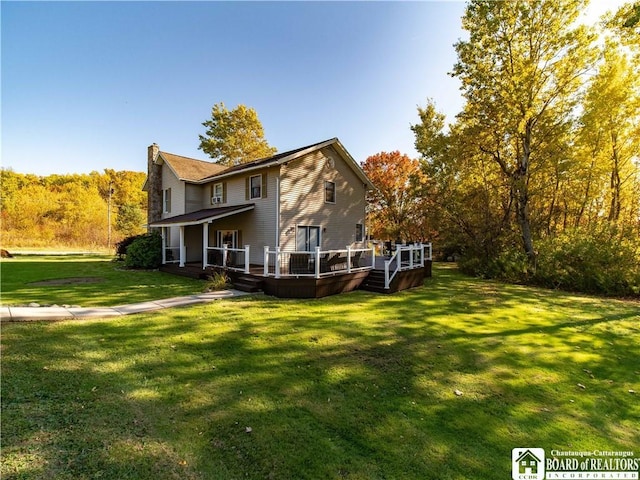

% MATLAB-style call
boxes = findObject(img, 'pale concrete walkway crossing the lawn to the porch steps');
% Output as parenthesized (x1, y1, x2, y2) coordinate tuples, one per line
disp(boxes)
(0, 290, 249, 323)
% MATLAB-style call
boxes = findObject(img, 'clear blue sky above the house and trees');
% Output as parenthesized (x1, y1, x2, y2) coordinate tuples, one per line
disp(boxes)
(1, 0, 620, 175)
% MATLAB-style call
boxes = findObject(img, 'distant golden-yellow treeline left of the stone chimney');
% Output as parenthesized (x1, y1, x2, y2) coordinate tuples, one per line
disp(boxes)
(0, 169, 147, 249)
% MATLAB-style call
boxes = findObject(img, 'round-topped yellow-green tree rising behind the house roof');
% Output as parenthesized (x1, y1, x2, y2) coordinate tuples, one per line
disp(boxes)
(198, 102, 277, 166)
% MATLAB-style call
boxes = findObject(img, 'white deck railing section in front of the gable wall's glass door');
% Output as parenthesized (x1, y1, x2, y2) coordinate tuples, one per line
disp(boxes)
(264, 247, 375, 278)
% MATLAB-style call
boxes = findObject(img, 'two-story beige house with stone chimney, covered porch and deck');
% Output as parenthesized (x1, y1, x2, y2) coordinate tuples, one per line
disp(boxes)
(144, 138, 432, 296)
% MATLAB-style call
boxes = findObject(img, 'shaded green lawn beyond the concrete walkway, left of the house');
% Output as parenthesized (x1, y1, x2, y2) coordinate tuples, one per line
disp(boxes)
(1, 255, 204, 307)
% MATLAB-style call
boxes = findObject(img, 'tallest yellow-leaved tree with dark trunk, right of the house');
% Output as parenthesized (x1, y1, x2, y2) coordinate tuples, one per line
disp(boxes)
(452, 0, 595, 261)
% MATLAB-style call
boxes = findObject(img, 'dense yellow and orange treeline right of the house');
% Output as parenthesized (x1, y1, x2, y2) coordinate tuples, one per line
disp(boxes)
(364, 0, 640, 295)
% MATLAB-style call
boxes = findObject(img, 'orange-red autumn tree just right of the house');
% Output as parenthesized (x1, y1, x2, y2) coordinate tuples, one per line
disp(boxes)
(362, 151, 428, 240)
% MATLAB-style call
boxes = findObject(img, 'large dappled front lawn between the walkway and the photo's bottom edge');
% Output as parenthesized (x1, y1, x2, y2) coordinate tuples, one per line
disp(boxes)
(1, 266, 640, 480)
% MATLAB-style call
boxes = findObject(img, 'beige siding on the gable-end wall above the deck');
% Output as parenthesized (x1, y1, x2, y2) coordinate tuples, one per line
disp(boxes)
(280, 147, 365, 250)
